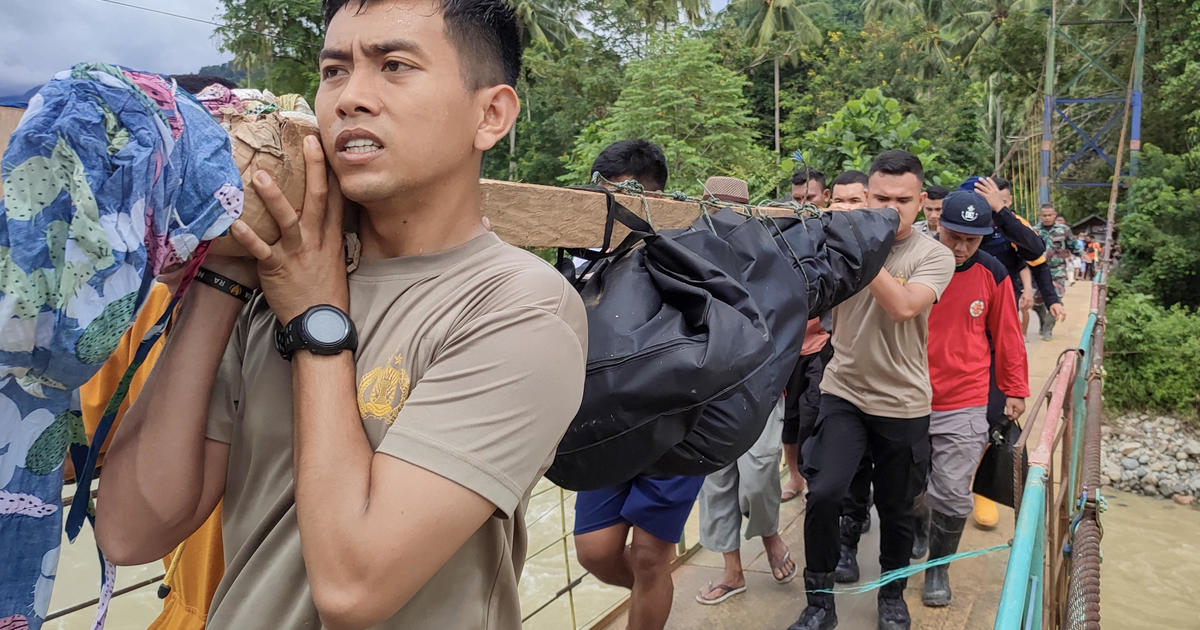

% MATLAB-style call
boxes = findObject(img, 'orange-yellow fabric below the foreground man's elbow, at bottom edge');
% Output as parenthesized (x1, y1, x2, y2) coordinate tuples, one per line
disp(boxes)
(148, 503, 224, 630)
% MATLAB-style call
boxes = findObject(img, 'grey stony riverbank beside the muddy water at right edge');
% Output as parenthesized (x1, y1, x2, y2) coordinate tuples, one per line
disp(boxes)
(1100, 414, 1200, 505)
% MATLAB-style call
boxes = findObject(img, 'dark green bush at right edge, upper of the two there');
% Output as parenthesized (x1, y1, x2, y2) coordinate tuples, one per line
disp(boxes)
(1115, 151, 1200, 308)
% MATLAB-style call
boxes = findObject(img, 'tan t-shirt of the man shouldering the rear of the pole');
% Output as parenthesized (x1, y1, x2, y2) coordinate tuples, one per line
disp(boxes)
(821, 232, 954, 418)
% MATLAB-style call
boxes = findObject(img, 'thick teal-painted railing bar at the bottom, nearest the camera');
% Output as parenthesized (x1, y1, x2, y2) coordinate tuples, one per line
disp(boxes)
(994, 466, 1046, 630)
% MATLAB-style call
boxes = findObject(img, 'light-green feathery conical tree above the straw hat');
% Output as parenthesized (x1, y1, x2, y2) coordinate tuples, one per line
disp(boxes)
(559, 31, 775, 194)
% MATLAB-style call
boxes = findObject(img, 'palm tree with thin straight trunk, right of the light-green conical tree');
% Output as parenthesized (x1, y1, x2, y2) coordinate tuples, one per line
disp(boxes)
(730, 0, 829, 160)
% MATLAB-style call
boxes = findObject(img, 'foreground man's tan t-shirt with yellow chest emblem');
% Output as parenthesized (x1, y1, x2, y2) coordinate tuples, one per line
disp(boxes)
(208, 234, 587, 630)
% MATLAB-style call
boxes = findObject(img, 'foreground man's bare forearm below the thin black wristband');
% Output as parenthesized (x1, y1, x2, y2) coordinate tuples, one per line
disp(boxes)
(96, 287, 241, 557)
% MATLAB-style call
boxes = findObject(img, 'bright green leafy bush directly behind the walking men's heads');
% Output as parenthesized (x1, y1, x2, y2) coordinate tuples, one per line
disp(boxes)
(804, 88, 962, 186)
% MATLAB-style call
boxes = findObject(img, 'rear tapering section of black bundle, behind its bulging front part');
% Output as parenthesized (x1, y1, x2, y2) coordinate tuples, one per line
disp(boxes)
(647, 209, 900, 475)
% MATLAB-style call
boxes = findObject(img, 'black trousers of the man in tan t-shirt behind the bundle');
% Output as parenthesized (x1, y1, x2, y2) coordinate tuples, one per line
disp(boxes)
(804, 394, 929, 578)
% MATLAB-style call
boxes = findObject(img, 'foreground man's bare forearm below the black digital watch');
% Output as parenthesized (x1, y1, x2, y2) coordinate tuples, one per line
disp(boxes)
(292, 352, 373, 614)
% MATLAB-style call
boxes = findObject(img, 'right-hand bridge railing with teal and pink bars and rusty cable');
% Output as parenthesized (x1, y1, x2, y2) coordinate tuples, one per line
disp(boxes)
(995, 271, 1108, 630)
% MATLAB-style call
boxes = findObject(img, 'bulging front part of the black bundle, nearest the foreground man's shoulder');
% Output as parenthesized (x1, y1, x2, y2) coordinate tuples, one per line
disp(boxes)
(546, 191, 774, 490)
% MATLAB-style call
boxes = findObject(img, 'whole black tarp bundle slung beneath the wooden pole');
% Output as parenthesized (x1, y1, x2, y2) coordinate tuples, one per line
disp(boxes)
(546, 196, 899, 490)
